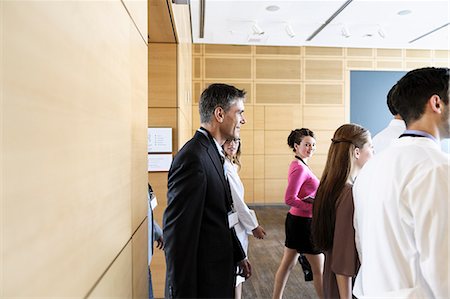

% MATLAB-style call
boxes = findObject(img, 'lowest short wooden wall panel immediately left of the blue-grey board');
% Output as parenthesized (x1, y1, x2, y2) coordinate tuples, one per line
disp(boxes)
(305, 84, 344, 105)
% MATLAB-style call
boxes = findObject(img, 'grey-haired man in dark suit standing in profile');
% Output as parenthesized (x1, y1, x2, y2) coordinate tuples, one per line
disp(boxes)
(163, 84, 251, 298)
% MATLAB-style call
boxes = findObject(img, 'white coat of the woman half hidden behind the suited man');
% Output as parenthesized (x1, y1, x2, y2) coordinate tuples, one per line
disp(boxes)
(224, 159, 259, 285)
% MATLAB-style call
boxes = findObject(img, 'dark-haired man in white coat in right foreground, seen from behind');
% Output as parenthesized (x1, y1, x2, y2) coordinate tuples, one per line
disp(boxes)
(353, 68, 450, 299)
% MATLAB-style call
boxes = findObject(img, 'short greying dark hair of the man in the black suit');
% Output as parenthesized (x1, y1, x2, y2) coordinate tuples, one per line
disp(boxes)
(198, 83, 246, 123)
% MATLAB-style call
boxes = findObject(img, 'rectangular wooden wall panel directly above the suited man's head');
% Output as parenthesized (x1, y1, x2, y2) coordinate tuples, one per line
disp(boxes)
(205, 57, 252, 79)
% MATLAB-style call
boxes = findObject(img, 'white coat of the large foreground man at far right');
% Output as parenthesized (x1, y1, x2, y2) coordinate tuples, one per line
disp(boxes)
(353, 137, 450, 299)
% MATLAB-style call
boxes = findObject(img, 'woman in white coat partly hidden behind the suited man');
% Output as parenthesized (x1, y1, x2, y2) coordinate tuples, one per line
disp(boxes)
(222, 138, 266, 299)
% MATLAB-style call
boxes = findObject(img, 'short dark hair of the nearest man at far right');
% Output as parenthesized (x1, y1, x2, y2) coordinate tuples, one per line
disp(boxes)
(392, 67, 450, 125)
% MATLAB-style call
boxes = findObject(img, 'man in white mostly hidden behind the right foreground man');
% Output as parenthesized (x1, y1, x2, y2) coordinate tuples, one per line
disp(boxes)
(372, 85, 406, 154)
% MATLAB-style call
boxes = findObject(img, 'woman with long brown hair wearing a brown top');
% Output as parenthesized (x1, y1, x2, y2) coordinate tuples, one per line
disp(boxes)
(312, 124, 373, 299)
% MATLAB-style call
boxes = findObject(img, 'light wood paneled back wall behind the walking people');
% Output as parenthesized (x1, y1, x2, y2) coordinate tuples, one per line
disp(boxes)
(192, 44, 450, 204)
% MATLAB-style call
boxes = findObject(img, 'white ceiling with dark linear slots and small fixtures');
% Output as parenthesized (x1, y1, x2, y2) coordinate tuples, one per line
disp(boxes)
(190, 0, 450, 50)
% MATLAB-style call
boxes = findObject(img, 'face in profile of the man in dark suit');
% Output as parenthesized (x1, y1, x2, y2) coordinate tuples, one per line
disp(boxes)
(220, 99, 246, 139)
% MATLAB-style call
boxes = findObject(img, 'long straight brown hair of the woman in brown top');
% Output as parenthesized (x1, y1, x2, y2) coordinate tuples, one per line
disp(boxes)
(311, 124, 370, 250)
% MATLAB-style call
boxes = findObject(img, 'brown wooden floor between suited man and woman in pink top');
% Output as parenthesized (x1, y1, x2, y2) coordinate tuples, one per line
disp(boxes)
(242, 206, 317, 299)
